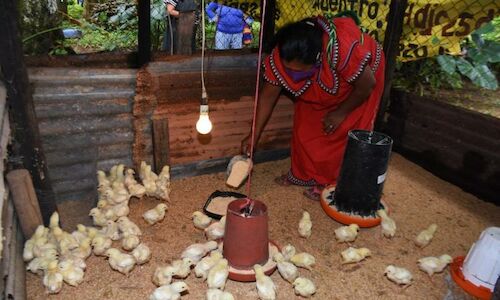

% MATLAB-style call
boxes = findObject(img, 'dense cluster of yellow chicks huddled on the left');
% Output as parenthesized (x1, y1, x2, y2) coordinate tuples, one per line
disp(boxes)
(23, 162, 170, 294)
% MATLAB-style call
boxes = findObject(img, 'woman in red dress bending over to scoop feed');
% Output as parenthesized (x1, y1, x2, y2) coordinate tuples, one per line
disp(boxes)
(242, 17, 385, 200)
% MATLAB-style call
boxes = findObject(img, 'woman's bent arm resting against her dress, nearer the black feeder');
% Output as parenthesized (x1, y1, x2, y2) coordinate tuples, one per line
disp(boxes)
(323, 66, 376, 134)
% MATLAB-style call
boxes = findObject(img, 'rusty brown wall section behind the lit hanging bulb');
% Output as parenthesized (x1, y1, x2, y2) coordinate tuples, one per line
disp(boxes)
(134, 55, 293, 172)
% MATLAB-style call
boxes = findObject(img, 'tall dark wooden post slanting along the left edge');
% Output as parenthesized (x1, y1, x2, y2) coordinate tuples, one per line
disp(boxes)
(0, 0, 56, 225)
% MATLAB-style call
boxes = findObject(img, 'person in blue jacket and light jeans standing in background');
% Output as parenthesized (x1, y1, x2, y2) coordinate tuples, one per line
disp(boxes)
(205, 2, 253, 50)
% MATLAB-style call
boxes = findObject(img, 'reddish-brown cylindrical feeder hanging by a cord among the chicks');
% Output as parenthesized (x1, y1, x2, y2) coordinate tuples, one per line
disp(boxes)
(223, 199, 278, 281)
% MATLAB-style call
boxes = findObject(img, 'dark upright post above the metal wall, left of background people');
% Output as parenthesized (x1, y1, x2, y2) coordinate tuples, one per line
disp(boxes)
(137, 0, 151, 67)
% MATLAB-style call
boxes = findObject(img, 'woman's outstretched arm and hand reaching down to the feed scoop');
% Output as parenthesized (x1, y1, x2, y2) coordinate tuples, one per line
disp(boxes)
(241, 82, 281, 154)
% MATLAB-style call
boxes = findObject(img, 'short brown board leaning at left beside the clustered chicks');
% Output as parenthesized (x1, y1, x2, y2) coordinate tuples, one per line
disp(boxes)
(7, 169, 43, 239)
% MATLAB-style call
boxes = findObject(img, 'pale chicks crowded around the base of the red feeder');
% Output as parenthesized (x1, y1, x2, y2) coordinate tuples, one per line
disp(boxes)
(149, 211, 316, 300)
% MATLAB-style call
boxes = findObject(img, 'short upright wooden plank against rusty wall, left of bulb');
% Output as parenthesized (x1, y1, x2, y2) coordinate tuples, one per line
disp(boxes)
(152, 114, 170, 173)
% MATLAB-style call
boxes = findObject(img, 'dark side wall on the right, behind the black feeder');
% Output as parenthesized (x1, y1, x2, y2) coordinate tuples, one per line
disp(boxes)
(387, 90, 500, 204)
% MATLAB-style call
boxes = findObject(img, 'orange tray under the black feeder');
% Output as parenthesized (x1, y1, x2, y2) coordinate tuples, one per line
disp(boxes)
(320, 186, 388, 228)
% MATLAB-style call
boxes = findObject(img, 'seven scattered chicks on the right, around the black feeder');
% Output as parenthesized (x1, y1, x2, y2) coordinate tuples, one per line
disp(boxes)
(298, 209, 452, 286)
